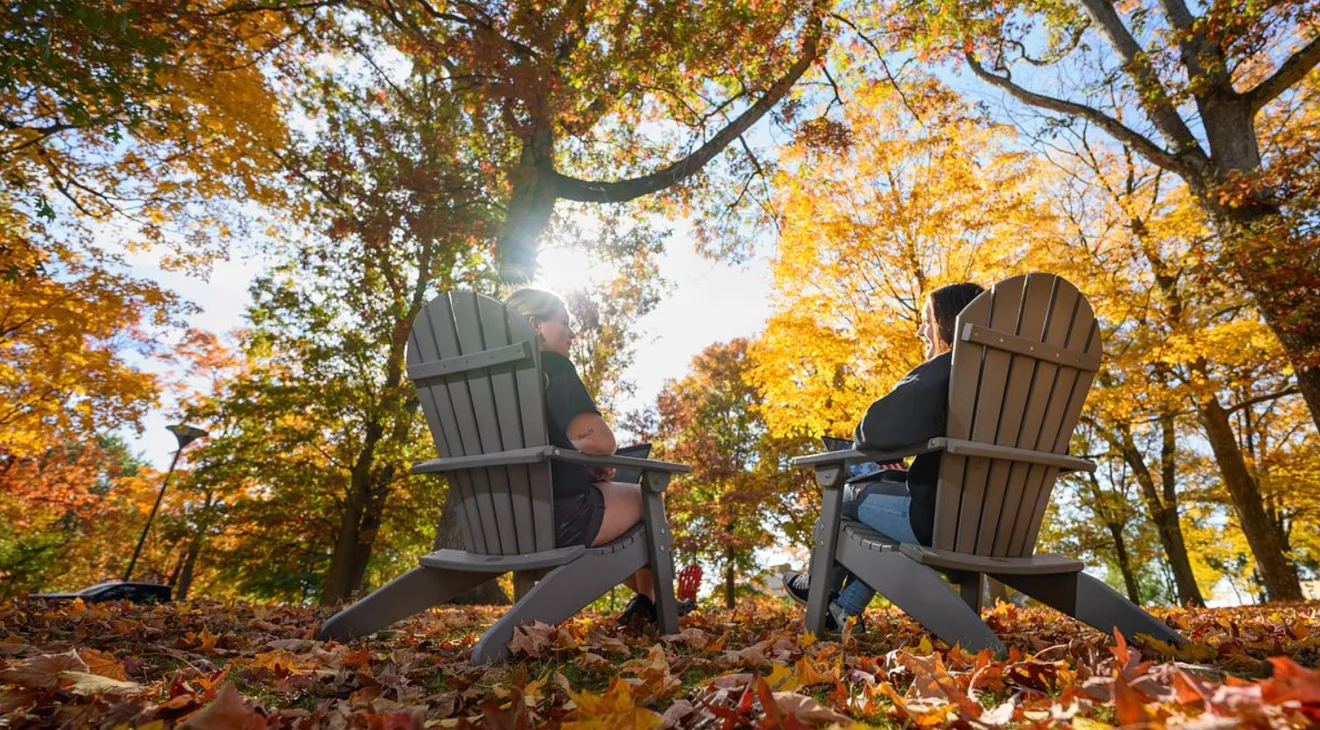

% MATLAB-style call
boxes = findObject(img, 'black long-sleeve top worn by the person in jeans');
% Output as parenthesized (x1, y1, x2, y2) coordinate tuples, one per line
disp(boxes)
(853, 352, 953, 545)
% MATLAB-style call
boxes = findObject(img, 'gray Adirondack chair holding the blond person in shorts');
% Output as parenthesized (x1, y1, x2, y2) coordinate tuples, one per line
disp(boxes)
(318, 292, 689, 664)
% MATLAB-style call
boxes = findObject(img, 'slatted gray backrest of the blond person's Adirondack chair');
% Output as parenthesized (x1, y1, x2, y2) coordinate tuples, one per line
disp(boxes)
(408, 292, 554, 554)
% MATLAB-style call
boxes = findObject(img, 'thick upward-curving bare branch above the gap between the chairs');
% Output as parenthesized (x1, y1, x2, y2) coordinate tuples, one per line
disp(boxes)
(548, 12, 824, 203)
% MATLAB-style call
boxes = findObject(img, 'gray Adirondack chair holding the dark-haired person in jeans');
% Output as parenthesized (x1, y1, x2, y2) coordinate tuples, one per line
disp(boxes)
(793, 273, 1183, 652)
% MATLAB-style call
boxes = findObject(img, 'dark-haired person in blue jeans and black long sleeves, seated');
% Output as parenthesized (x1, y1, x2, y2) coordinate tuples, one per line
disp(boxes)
(784, 284, 983, 631)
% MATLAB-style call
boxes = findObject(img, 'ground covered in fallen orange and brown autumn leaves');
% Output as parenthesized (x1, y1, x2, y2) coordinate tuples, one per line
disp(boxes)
(0, 601, 1320, 730)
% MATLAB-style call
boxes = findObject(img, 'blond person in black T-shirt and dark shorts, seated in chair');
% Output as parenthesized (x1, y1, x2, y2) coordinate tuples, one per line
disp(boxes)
(506, 289, 690, 623)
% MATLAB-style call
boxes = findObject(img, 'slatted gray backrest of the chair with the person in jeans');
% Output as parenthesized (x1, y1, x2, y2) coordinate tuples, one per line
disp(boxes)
(935, 273, 1101, 557)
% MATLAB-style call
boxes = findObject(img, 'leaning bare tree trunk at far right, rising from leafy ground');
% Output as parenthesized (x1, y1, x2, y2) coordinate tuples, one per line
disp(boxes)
(1197, 395, 1303, 601)
